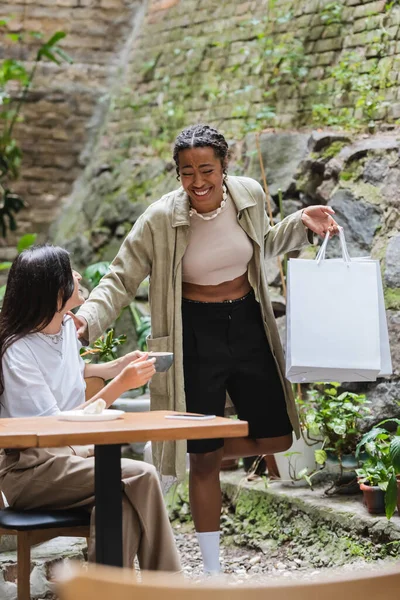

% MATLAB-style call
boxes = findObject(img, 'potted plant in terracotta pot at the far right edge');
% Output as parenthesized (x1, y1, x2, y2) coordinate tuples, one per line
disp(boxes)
(356, 419, 400, 519)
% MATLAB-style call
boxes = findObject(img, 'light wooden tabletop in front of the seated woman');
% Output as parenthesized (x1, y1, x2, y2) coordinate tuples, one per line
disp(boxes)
(0, 411, 248, 448)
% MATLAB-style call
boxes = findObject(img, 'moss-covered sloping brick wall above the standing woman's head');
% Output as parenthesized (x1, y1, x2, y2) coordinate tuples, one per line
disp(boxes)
(104, 0, 400, 159)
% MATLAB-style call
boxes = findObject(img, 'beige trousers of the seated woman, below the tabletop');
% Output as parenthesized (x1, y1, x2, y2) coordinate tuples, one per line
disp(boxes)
(0, 446, 181, 572)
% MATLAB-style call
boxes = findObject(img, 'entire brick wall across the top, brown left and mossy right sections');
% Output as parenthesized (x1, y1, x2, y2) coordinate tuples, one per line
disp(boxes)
(0, 0, 400, 251)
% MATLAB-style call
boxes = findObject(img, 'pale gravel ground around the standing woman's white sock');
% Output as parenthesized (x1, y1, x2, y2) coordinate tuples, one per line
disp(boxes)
(174, 524, 396, 583)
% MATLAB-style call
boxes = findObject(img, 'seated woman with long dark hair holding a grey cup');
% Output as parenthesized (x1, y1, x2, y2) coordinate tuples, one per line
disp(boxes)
(0, 245, 181, 571)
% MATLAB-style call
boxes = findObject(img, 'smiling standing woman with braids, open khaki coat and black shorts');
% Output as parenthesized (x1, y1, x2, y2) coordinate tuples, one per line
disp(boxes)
(73, 125, 337, 572)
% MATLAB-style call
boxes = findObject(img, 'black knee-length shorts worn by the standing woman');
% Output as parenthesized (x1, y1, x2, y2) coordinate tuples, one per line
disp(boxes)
(182, 292, 292, 453)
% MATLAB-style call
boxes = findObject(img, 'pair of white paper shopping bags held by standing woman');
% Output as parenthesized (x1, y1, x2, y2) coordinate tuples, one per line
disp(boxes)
(286, 230, 391, 383)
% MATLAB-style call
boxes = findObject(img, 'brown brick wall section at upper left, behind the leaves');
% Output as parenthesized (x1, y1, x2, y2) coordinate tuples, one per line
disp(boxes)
(0, 0, 145, 259)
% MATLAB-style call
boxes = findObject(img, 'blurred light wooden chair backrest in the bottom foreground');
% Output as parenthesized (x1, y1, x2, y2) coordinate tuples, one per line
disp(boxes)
(59, 563, 400, 600)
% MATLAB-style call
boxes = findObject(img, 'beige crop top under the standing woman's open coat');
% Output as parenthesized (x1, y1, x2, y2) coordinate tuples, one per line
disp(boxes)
(182, 196, 253, 285)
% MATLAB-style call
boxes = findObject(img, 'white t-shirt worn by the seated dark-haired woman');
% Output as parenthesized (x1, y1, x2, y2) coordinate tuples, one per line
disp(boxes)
(0, 316, 85, 418)
